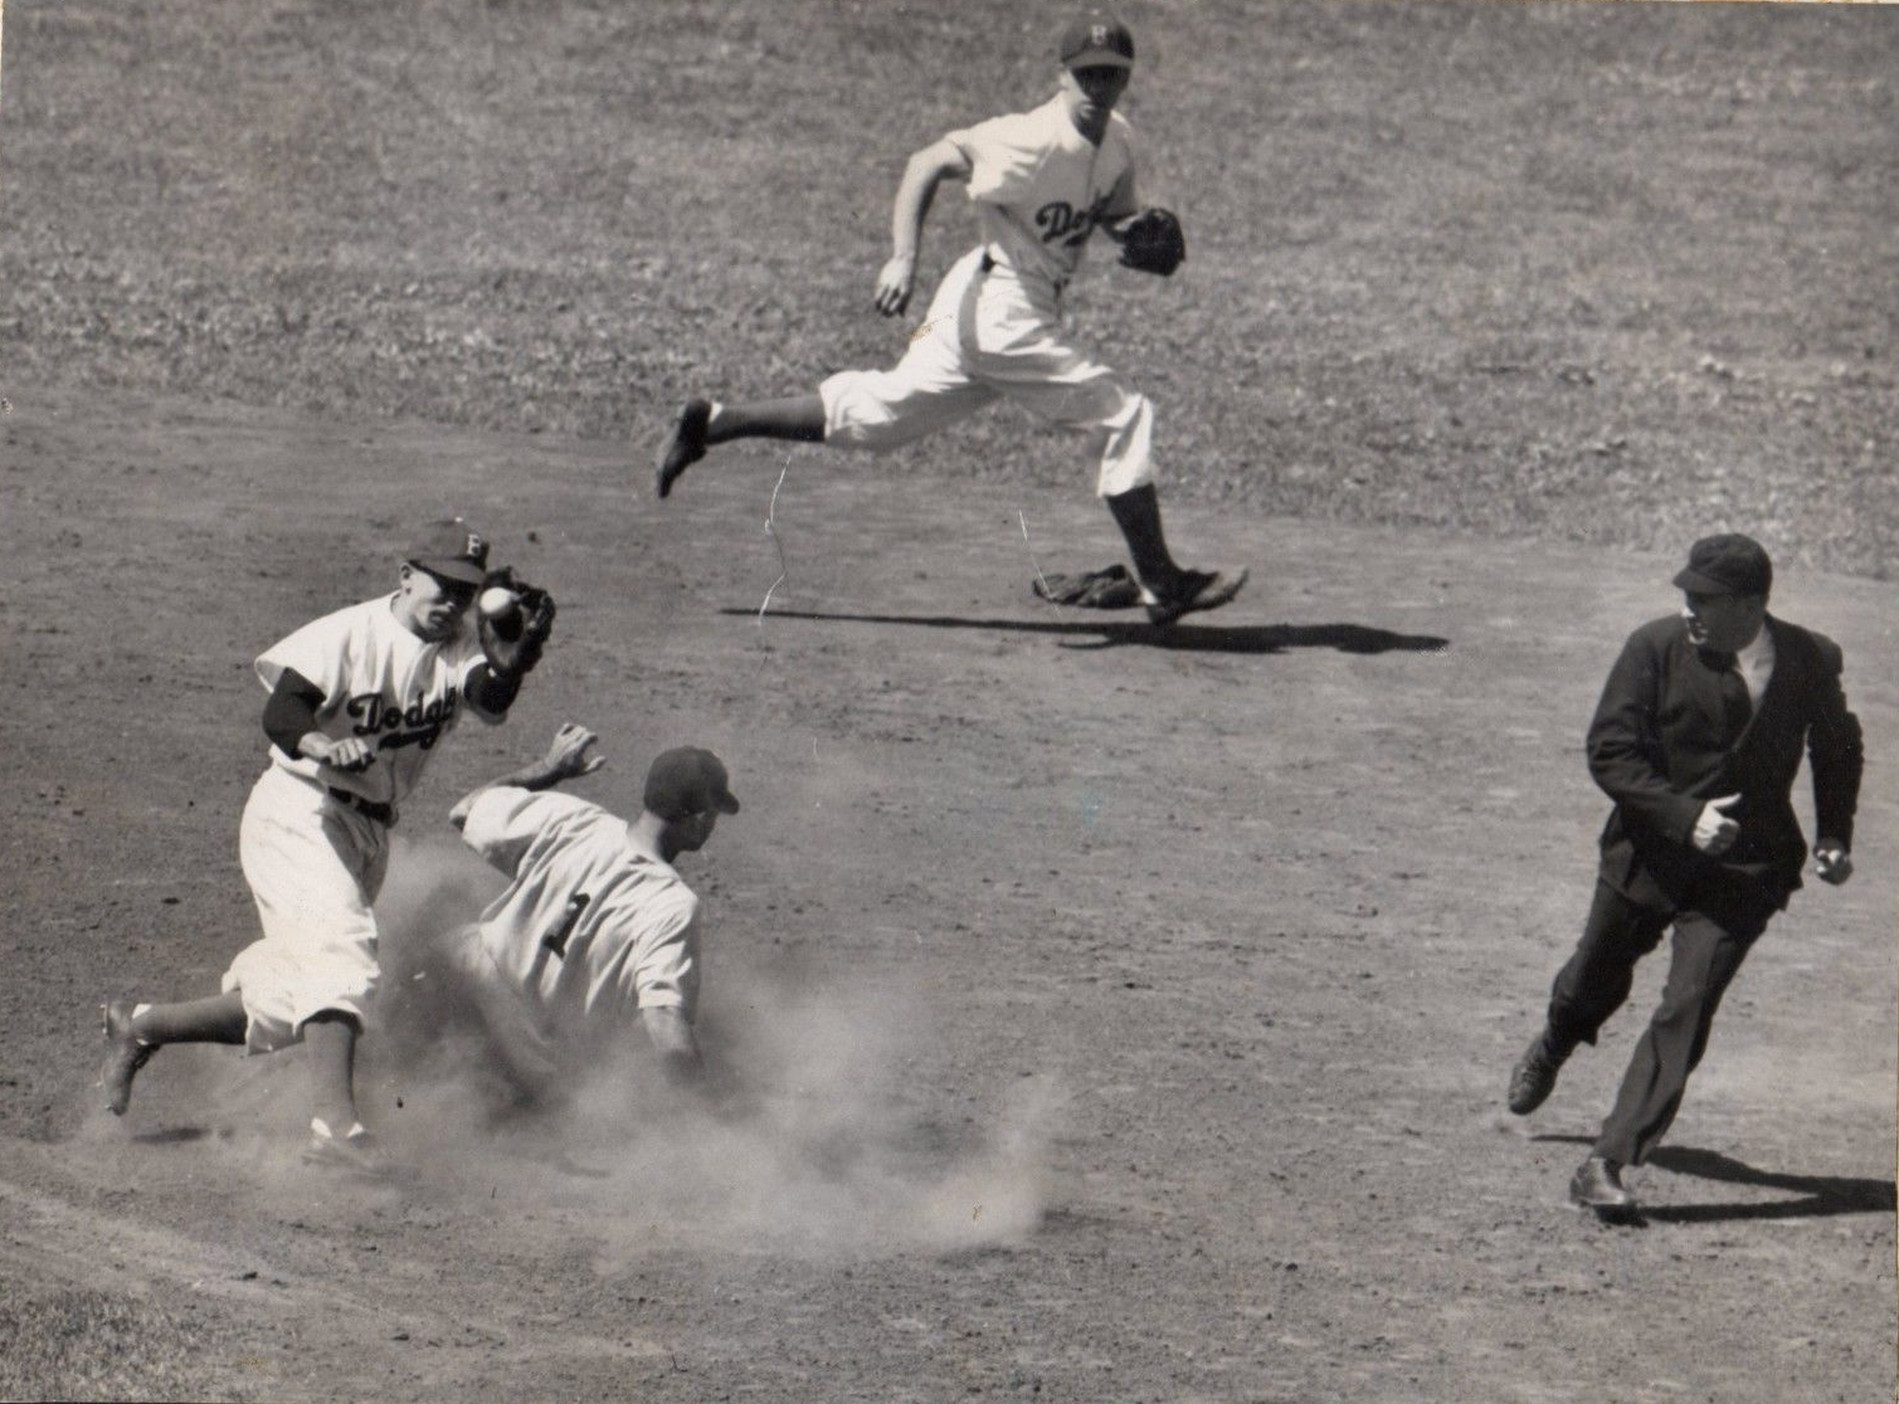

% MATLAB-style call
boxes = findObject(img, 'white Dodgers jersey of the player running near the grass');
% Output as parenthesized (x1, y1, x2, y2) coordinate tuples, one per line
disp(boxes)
(944, 97, 1134, 283)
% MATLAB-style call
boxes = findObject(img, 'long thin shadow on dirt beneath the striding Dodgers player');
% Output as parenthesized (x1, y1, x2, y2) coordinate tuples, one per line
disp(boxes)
(720, 610, 1451, 654)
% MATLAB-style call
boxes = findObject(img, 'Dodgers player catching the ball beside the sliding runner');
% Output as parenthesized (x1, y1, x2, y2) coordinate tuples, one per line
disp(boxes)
(101, 519, 555, 1170)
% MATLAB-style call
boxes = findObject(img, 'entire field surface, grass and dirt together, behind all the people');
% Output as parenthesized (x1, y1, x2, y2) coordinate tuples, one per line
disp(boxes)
(0, 0, 1899, 1404)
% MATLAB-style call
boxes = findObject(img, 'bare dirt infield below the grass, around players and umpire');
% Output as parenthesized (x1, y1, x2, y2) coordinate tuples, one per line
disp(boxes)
(0, 383, 1899, 1402)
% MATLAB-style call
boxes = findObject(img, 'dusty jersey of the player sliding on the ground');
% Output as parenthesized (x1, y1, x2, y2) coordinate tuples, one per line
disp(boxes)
(461, 785, 699, 1020)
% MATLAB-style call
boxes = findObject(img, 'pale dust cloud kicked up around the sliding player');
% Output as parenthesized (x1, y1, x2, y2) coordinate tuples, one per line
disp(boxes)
(361, 844, 1063, 1267)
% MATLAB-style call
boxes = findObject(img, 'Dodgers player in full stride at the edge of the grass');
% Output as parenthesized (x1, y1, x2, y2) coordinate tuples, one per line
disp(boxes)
(657, 13, 1246, 625)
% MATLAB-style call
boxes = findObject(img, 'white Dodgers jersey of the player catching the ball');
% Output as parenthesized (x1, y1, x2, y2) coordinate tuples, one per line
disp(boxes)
(256, 595, 484, 804)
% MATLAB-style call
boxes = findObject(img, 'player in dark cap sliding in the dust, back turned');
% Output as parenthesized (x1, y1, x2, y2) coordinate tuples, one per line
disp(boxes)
(441, 724, 739, 1098)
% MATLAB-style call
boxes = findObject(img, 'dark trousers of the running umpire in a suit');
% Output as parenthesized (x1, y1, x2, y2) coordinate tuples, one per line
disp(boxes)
(1550, 882, 1776, 1165)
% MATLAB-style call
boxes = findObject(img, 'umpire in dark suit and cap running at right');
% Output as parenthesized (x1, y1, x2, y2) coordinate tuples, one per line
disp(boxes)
(1510, 536, 1863, 1216)
